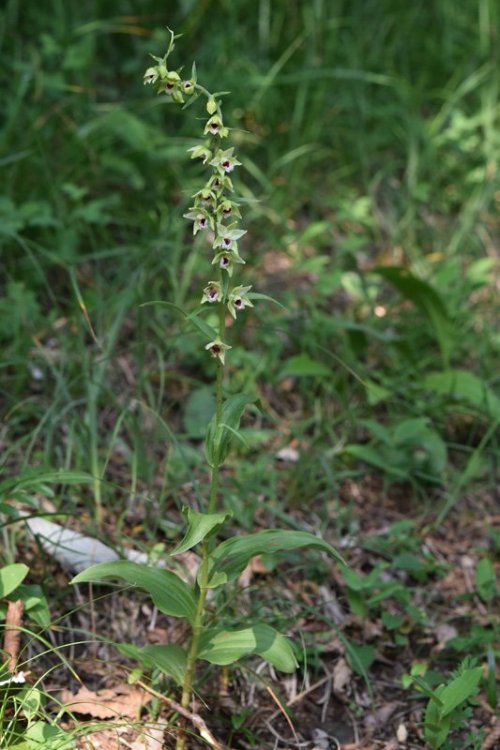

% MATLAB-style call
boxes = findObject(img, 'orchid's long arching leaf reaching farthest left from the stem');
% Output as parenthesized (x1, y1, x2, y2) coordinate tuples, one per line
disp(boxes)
(71, 560, 196, 622)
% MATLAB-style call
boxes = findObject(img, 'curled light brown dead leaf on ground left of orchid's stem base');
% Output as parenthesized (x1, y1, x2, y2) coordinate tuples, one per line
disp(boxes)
(60, 684, 151, 719)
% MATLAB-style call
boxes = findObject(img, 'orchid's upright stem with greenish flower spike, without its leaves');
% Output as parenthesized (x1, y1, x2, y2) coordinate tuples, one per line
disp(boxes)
(144, 31, 253, 750)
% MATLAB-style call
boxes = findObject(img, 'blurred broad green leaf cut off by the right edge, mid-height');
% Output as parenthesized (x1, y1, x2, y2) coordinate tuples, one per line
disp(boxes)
(423, 370, 500, 420)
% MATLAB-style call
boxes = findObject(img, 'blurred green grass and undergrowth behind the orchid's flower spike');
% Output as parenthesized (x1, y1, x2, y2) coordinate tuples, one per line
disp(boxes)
(0, 0, 500, 524)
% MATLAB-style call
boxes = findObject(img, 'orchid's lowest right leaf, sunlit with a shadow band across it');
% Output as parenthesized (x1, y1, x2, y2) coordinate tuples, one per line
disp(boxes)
(198, 625, 298, 672)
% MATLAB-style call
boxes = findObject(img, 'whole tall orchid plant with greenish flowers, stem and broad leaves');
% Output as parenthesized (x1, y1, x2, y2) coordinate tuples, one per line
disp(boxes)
(73, 32, 343, 750)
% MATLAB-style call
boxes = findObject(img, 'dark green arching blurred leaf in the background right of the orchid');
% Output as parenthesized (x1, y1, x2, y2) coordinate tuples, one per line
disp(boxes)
(373, 266, 453, 362)
